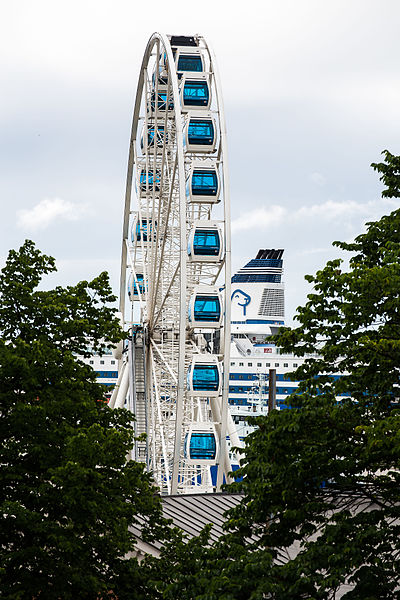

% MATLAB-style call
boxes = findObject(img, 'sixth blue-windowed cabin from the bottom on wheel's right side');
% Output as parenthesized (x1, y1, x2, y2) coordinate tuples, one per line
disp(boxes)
(183, 112, 217, 153)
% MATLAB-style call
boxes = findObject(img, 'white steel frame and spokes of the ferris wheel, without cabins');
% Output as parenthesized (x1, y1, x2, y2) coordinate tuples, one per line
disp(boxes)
(110, 33, 240, 494)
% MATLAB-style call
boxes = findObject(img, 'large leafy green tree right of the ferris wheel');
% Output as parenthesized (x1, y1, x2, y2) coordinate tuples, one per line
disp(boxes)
(149, 151, 400, 600)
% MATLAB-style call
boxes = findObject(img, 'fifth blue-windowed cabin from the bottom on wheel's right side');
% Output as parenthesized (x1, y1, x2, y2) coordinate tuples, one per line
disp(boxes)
(186, 160, 220, 204)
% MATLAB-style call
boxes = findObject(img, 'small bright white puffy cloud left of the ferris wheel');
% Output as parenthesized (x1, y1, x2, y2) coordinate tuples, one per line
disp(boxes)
(17, 198, 88, 231)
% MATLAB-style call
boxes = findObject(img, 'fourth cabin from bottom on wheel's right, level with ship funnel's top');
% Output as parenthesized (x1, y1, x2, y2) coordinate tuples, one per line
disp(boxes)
(188, 220, 223, 262)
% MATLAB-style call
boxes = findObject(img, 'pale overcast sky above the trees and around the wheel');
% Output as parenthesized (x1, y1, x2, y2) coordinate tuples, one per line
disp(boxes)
(0, 0, 400, 322)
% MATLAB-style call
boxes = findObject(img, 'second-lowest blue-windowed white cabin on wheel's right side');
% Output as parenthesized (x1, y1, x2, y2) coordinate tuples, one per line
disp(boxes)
(186, 354, 222, 398)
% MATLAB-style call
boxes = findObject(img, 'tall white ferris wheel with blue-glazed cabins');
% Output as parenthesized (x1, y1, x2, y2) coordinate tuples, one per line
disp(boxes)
(110, 33, 239, 494)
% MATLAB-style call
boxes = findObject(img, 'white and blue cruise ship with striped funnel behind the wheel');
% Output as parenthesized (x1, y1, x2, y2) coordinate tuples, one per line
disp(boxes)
(85, 249, 303, 440)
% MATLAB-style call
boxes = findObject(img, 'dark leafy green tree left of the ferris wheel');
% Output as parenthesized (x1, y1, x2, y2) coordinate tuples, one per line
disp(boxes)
(0, 241, 163, 600)
